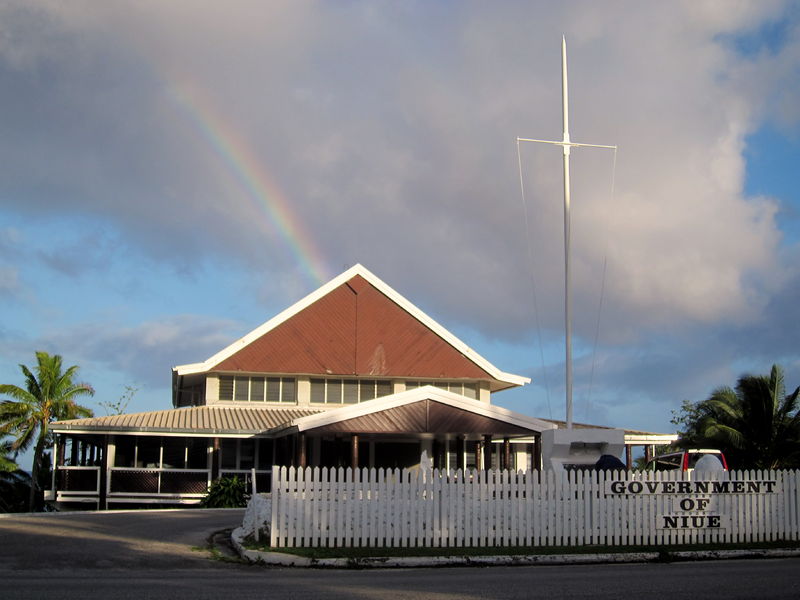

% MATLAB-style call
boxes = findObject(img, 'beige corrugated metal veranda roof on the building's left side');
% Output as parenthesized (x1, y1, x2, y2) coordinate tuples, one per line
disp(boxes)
(50, 406, 320, 436)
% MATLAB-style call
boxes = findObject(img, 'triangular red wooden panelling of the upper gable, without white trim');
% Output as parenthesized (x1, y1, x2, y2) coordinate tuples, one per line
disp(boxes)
(215, 275, 491, 379)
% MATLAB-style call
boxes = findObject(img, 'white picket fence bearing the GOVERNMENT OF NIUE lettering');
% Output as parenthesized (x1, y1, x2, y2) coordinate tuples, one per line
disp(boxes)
(269, 467, 800, 547)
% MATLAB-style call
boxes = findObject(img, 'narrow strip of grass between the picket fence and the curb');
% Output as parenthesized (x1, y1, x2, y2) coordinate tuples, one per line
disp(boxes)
(244, 539, 800, 560)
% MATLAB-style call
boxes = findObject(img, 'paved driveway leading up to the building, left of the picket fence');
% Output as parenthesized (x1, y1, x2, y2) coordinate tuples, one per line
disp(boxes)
(0, 509, 244, 570)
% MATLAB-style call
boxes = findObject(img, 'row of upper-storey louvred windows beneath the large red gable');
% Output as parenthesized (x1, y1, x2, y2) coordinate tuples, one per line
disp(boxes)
(219, 375, 478, 404)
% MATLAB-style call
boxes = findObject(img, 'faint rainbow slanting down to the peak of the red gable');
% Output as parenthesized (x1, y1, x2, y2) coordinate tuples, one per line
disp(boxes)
(170, 84, 330, 285)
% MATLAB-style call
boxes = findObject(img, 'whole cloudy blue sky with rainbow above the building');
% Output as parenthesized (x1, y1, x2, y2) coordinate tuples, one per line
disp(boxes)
(0, 0, 800, 468)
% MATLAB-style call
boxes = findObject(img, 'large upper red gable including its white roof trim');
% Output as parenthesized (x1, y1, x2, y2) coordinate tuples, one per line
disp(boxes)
(175, 265, 528, 388)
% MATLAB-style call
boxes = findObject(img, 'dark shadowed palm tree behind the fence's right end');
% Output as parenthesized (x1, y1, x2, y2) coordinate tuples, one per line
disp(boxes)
(673, 365, 800, 469)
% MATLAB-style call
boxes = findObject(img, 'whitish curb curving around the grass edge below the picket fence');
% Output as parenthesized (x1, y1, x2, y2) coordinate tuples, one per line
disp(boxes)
(231, 527, 800, 569)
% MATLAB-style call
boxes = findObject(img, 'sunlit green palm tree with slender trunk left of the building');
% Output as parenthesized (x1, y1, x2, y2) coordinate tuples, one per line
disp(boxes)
(0, 352, 94, 511)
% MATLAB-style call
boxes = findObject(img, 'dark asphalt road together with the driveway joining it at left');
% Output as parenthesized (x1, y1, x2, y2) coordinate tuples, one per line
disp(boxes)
(0, 511, 800, 600)
